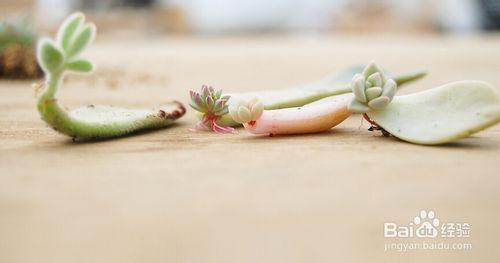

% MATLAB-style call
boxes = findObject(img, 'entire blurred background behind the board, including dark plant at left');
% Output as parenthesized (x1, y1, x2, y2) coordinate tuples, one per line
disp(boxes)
(0, 0, 500, 78)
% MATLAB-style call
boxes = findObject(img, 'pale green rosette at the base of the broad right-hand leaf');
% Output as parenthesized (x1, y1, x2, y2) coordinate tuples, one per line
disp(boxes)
(348, 62, 397, 113)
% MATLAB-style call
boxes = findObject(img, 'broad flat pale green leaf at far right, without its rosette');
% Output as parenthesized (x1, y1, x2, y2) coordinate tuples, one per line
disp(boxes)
(368, 80, 500, 144)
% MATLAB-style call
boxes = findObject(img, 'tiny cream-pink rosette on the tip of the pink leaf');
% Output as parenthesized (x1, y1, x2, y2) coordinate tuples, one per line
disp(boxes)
(229, 98, 264, 124)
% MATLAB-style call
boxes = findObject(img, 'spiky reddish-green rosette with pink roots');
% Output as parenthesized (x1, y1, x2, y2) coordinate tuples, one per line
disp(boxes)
(189, 85, 235, 133)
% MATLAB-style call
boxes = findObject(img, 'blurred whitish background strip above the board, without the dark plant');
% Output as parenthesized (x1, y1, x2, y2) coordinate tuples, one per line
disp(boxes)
(0, 0, 500, 34)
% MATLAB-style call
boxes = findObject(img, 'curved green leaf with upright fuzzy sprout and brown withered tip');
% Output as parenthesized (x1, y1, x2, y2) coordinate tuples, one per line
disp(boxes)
(37, 13, 186, 140)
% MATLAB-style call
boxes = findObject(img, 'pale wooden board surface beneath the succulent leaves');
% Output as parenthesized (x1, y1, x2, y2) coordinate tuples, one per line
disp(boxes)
(0, 35, 500, 263)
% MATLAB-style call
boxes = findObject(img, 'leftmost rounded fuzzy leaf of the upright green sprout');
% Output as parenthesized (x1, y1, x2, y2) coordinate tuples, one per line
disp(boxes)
(38, 39, 64, 72)
